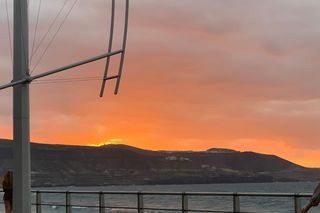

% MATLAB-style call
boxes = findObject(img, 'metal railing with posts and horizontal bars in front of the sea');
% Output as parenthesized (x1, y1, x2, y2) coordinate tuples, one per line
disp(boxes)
(0, 190, 312, 213)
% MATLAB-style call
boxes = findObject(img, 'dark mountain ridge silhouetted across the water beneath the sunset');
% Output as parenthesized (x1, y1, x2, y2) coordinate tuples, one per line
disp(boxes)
(0, 139, 320, 186)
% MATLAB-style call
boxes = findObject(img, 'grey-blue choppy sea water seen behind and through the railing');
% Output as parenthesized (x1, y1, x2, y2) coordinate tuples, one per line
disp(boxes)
(0, 182, 320, 213)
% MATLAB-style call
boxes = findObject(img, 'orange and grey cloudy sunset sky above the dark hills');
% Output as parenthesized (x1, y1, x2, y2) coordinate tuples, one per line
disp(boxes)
(0, 0, 320, 167)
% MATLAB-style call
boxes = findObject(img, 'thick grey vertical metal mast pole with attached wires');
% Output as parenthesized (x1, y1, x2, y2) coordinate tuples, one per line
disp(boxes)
(13, 0, 31, 213)
